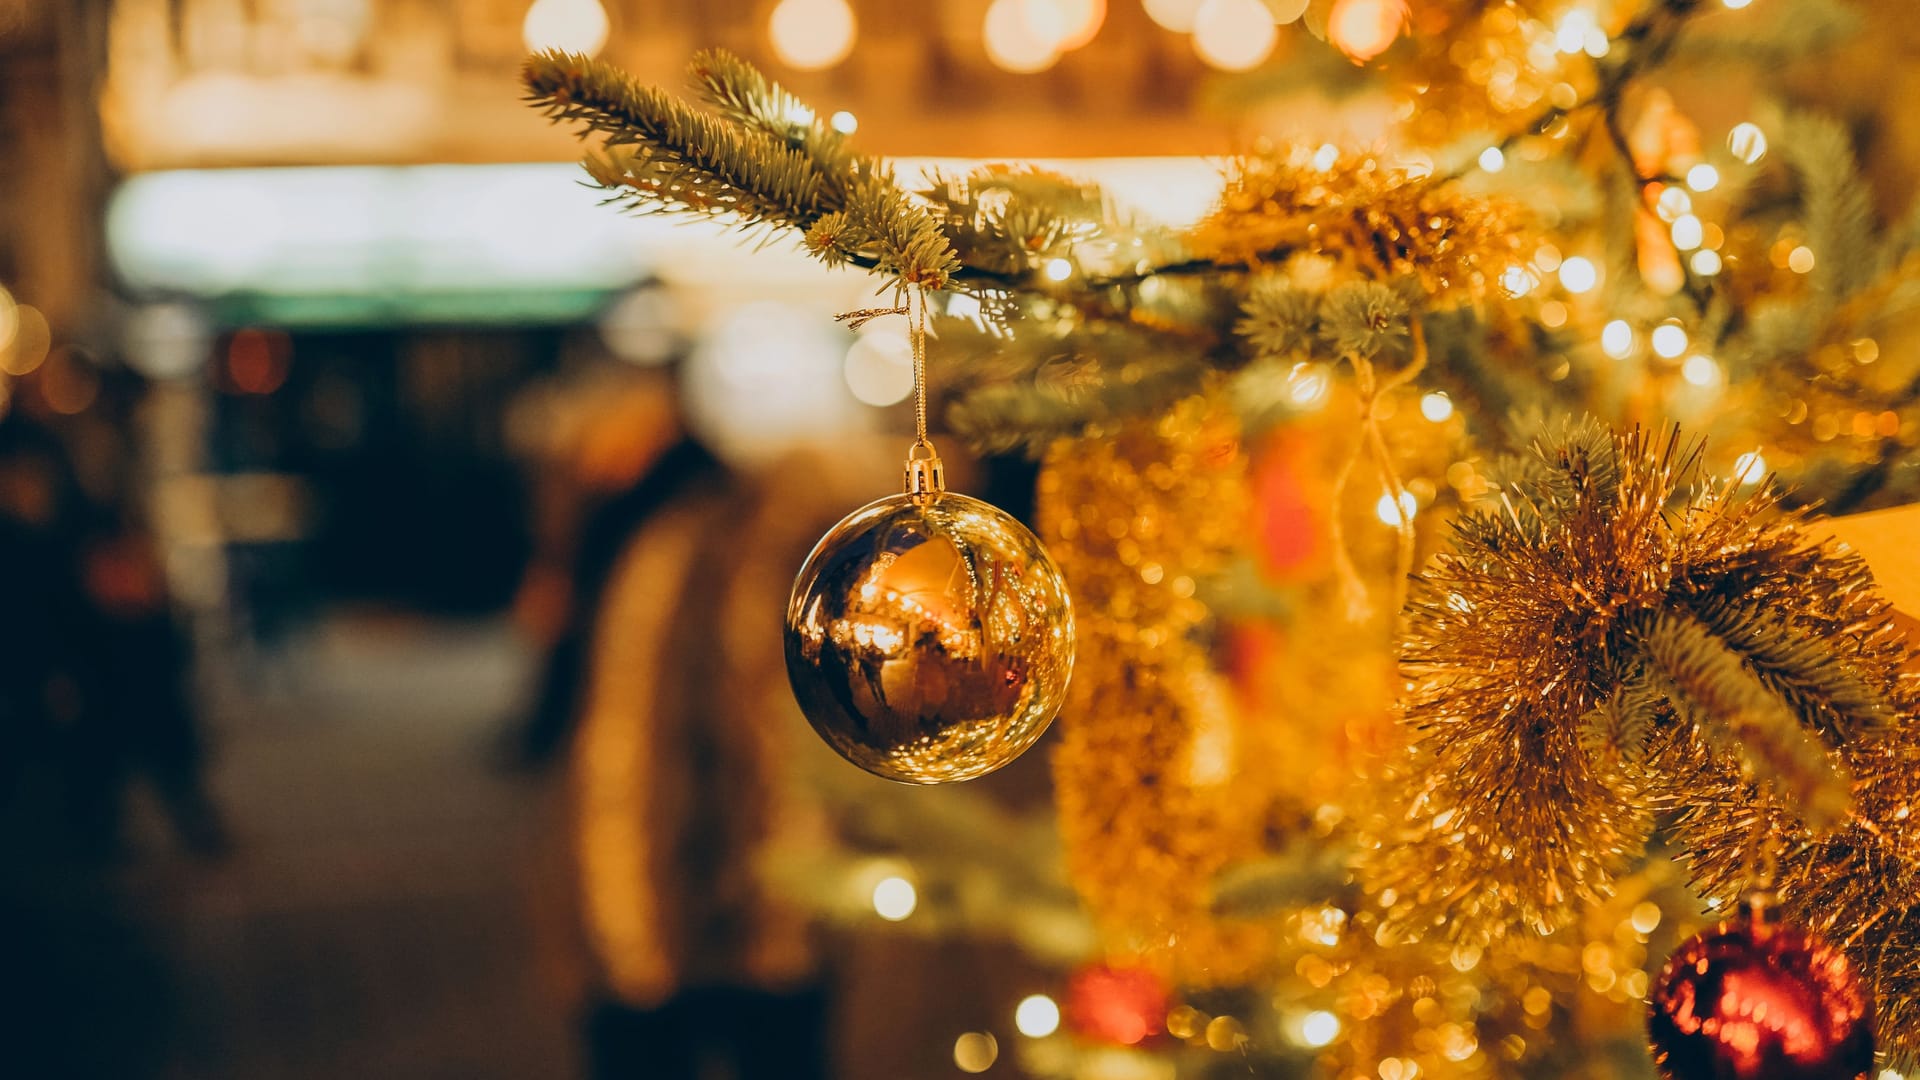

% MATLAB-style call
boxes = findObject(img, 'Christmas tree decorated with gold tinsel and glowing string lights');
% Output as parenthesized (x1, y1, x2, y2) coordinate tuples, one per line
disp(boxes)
(524, 0, 1920, 1080)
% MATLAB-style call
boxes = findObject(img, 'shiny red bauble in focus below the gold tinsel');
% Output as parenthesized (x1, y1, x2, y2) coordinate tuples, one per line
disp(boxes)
(1647, 917, 1874, 1080)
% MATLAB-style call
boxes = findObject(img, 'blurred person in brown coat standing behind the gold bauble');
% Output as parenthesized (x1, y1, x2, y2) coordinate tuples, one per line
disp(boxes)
(518, 365, 897, 1080)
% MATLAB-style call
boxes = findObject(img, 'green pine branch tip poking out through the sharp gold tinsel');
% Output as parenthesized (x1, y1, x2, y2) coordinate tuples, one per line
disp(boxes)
(1640, 611, 1851, 828)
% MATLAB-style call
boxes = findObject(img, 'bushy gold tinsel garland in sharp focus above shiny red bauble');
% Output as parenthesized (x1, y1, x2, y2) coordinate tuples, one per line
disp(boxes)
(1363, 417, 1920, 1061)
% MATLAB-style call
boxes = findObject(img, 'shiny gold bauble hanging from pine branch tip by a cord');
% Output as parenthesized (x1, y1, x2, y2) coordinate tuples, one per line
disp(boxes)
(787, 484, 1073, 784)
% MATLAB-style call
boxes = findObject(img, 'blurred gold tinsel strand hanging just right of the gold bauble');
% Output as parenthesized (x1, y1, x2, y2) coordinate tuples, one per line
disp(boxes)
(1039, 390, 1273, 984)
